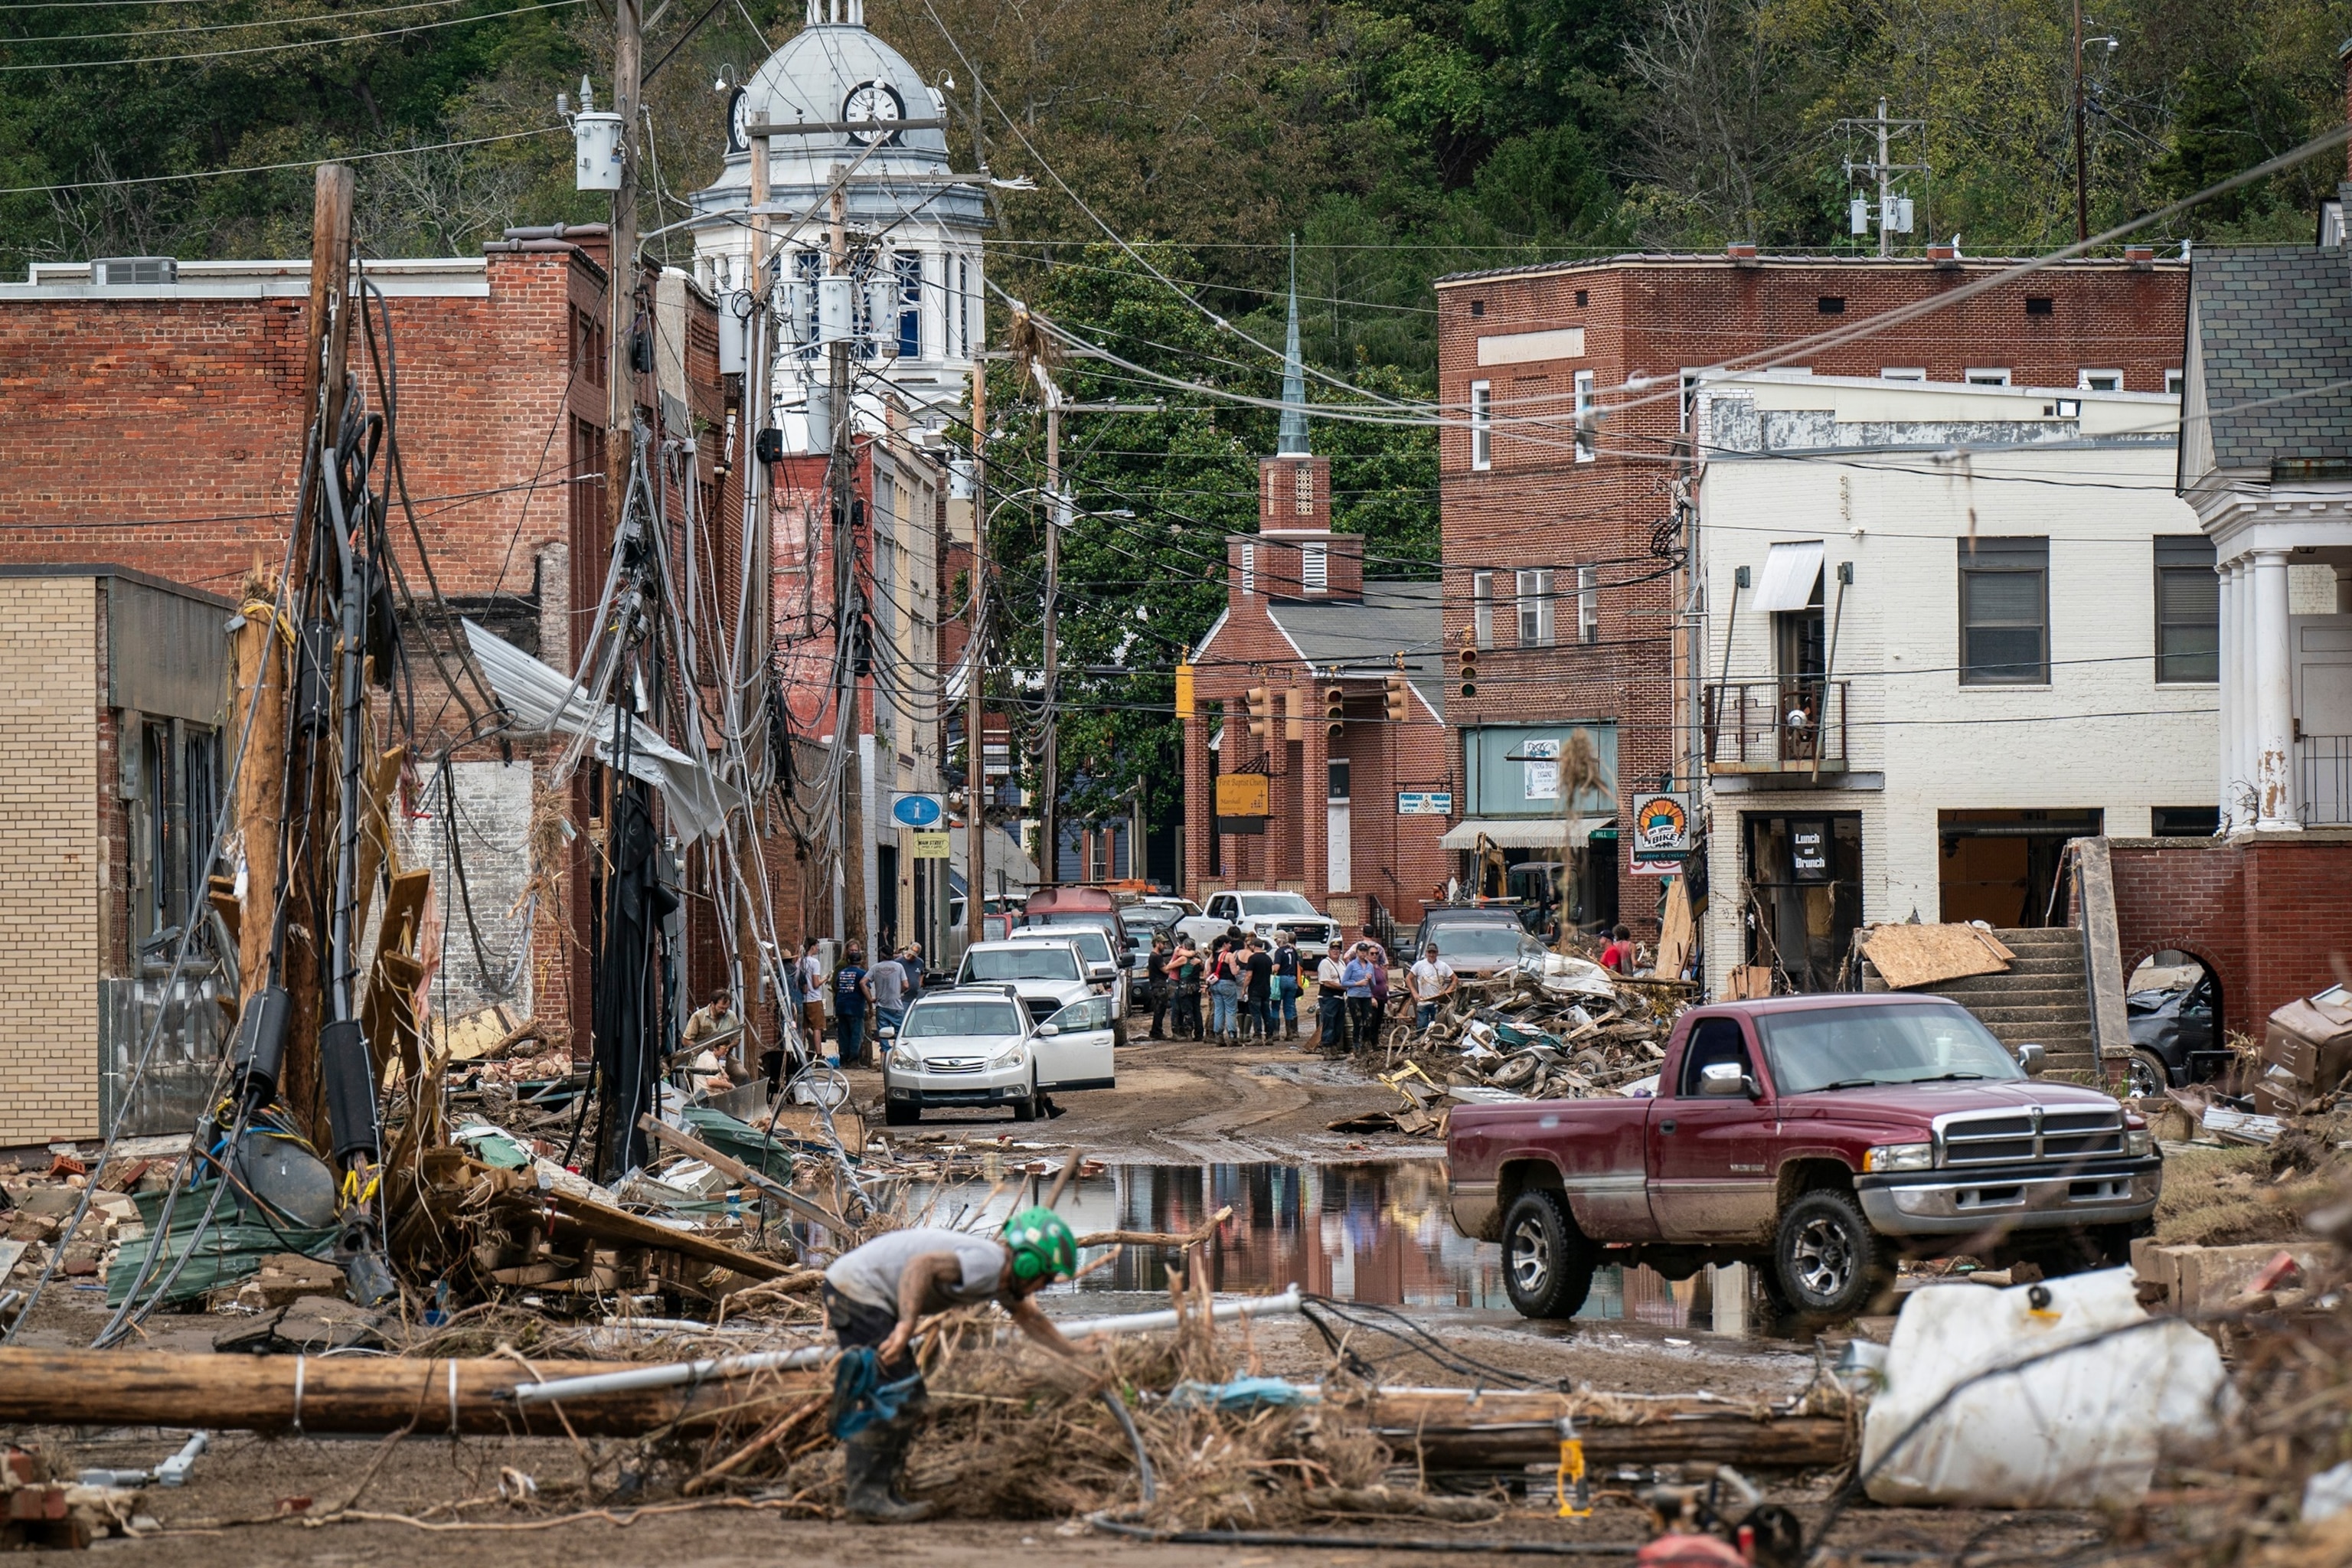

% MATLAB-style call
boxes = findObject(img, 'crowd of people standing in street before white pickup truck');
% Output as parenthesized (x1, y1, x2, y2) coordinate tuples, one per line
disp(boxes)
(1124, 926, 1420, 1050)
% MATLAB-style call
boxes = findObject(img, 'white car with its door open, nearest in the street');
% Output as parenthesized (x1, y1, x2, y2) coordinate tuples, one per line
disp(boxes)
(882, 982, 1117, 1126)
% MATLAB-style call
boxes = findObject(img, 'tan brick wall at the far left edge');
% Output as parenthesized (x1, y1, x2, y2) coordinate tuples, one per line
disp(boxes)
(0, 578, 103, 1145)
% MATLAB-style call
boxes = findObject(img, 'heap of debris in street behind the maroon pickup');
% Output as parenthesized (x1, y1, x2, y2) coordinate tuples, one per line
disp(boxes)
(1331, 952, 1698, 1138)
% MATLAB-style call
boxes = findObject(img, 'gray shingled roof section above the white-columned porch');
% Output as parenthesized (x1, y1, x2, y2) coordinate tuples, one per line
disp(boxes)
(2190, 244, 2352, 468)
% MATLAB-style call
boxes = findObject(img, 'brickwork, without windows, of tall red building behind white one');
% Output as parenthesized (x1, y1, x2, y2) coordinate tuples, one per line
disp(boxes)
(1437, 256, 2187, 931)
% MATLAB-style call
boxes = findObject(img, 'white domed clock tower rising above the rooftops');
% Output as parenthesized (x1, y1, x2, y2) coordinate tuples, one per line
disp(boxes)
(694, 0, 990, 452)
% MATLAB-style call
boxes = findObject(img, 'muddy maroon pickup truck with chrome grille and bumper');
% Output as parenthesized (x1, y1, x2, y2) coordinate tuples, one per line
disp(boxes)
(1446, 995, 2164, 1321)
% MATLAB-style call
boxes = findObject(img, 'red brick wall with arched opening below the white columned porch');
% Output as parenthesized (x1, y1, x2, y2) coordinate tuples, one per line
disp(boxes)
(2110, 828, 2352, 1037)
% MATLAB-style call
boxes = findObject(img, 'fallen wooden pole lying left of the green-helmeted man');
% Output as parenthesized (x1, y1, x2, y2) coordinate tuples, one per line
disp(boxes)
(0, 1349, 832, 1436)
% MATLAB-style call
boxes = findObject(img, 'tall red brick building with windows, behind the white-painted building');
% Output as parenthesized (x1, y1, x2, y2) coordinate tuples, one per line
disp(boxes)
(1437, 249, 2185, 931)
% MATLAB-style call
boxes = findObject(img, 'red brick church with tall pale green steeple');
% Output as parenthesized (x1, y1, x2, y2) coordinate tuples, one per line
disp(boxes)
(1176, 301, 1459, 924)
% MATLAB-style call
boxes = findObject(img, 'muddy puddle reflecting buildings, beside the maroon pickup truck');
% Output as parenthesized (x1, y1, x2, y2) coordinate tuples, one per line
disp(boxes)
(889, 1159, 1747, 1333)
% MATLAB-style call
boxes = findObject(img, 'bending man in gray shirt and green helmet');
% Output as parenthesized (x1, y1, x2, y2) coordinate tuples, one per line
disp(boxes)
(823, 1213, 1077, 1524)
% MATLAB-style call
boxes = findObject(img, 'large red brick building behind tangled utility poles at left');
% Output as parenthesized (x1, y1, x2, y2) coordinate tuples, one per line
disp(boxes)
(0, 240, 771, 1142)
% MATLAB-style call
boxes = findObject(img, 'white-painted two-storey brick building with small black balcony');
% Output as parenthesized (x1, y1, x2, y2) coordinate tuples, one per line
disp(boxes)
(1694, 371, 2220, 995)
